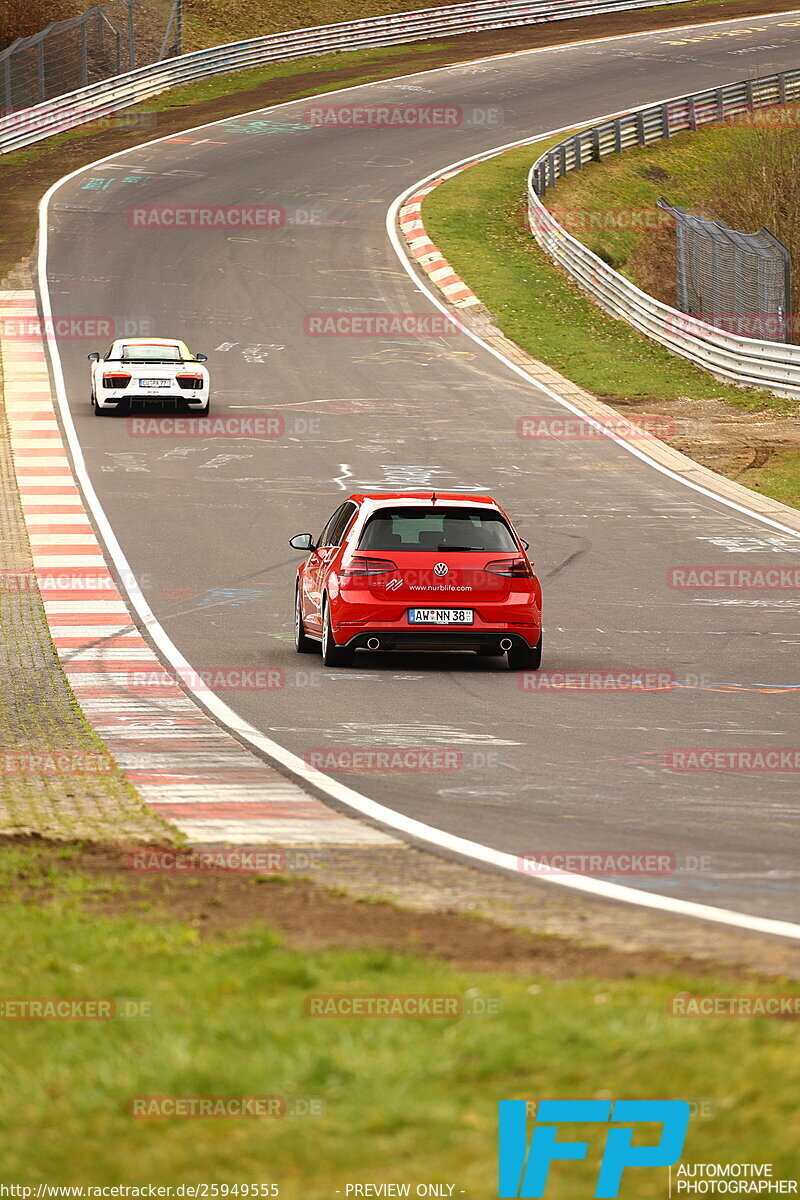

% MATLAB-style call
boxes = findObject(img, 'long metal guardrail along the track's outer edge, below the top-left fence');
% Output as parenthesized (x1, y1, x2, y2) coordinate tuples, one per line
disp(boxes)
(0, 0, 682, 154)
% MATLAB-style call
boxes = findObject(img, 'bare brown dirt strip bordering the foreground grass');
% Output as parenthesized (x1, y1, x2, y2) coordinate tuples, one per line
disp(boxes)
(0, 836, 796, 979)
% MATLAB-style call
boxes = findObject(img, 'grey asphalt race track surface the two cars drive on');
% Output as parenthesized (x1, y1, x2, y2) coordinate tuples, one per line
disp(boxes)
(40, 14, 800, 920)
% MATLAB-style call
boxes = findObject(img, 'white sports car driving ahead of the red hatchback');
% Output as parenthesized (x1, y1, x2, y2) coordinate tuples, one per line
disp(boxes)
(89, 337, 210, 416)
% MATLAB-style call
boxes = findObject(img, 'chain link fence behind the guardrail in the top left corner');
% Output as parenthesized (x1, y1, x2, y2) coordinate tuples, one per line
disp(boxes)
(0, 0, 182, 113)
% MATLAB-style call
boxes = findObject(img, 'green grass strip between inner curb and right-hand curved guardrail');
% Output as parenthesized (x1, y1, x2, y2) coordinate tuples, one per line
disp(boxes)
(423, 141, 796, 413)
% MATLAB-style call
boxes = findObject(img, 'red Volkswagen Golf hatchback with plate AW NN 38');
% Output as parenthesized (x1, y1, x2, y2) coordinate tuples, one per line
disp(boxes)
(289, 492, 542, 671)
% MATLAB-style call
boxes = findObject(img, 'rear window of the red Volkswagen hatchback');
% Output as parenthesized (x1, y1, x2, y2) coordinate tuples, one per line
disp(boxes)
(359, 505, 518, 554)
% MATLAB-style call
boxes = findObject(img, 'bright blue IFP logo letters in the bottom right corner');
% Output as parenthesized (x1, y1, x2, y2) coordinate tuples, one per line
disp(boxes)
(498, 1100, 690, 1200)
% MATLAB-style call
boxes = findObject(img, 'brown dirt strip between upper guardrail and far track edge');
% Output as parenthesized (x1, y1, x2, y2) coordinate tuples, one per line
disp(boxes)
(0, 0, 798, 288)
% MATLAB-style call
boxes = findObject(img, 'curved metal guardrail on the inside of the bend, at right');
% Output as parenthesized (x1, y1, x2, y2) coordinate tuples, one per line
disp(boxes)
(528, 71, 800, 398)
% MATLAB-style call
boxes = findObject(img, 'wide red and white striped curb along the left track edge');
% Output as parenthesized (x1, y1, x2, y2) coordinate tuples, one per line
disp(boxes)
(0, 292, 397, 846)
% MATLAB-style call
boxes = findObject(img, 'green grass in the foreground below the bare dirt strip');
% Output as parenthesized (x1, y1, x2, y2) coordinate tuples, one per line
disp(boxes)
(0, 850, 800, 1200)
